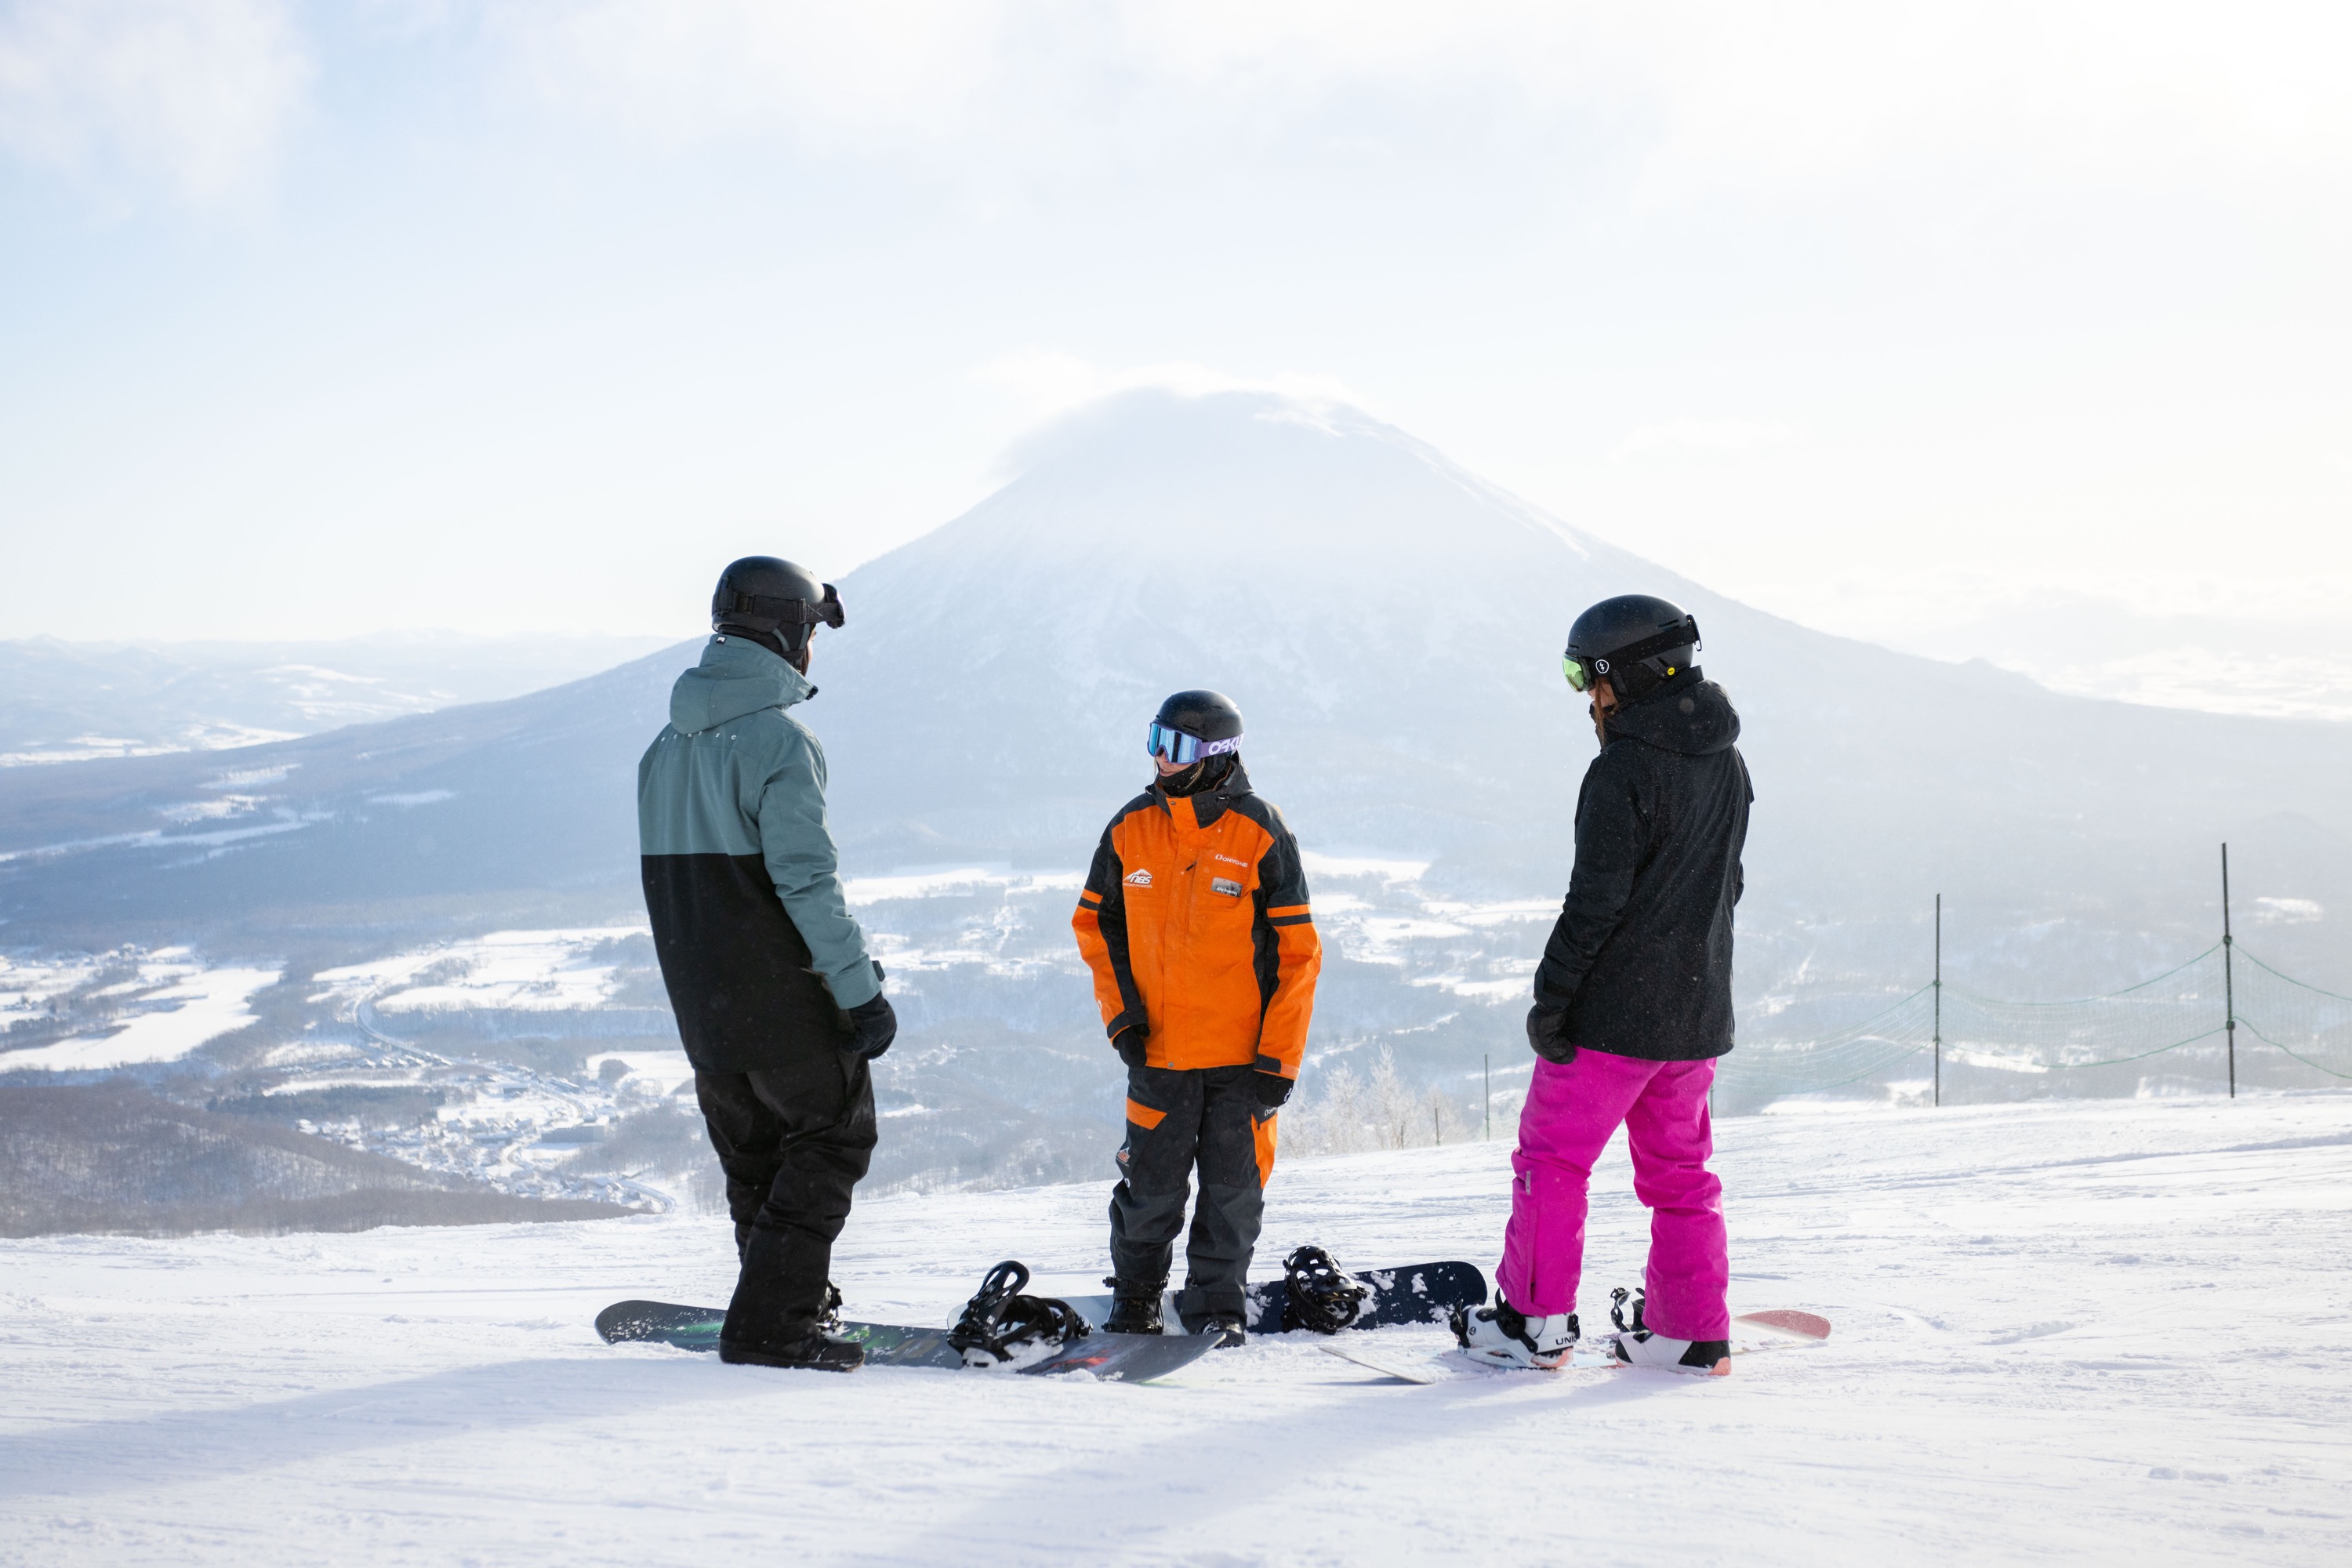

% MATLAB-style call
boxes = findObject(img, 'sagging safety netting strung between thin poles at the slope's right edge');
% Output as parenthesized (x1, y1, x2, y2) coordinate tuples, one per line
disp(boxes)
(1717, 942, 2352, 1112)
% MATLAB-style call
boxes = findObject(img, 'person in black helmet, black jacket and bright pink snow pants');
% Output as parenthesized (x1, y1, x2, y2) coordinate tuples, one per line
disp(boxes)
(1454, 595, 1755, 1373)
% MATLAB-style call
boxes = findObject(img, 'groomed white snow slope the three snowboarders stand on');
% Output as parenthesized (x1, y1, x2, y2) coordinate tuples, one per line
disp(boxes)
(0, 1093, 2352, 1568)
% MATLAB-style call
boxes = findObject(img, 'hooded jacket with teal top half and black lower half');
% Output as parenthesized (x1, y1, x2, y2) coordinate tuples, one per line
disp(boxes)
(637, 637, 882, 1072)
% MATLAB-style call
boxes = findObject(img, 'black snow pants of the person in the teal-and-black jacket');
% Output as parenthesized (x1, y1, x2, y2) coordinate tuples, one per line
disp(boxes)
(694, 1036, 875, 1345)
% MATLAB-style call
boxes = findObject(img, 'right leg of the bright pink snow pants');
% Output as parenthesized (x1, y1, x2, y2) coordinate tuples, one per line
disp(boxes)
(1625, 1060, 1731, 1340)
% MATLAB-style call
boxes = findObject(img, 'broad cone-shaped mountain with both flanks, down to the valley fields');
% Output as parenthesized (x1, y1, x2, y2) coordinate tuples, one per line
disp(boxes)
(0, 393, 2352, 982)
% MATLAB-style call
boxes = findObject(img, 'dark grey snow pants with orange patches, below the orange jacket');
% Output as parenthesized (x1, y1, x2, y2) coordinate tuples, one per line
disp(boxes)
(1110, 1065, 1275, 1328)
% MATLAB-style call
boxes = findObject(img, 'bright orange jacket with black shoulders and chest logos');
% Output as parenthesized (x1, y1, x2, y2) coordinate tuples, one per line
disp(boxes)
(1070, 762, 1322, 1079)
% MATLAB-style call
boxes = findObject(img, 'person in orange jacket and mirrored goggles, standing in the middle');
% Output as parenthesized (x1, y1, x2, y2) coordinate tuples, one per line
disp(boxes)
(1070, 691, 1322, 1345)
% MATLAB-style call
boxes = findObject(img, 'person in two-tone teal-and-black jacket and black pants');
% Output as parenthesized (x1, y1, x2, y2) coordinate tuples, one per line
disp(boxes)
(637, 555, 898, 1373)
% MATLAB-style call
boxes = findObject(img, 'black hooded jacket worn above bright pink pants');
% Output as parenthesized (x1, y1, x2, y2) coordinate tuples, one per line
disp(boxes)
(1536, 668, 1755, 1062)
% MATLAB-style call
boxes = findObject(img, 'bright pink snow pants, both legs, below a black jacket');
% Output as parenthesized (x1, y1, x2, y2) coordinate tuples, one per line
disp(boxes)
(1496, 1051, 1731, 1340)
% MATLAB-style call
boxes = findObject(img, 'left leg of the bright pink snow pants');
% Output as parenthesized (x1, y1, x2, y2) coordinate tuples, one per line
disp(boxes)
(1496, 1051, 1668, 1316)
